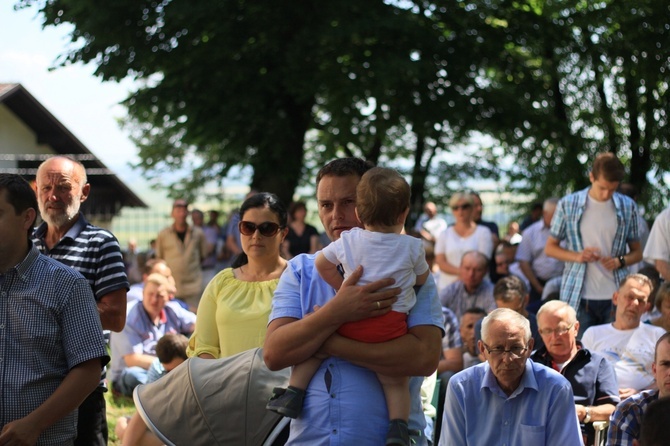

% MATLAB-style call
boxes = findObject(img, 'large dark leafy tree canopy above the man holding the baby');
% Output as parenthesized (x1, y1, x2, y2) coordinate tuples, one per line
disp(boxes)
(23, 0, 478, 206)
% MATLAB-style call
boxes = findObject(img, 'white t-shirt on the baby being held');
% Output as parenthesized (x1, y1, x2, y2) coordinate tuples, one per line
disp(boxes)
(321, 228, 428, 313)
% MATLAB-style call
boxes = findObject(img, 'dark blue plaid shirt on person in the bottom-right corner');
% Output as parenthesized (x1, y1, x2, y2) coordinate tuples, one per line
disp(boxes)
(607, 390, 658, 446)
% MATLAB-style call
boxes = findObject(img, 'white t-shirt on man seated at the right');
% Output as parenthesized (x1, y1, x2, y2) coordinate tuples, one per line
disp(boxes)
(582, 324, 665, 391)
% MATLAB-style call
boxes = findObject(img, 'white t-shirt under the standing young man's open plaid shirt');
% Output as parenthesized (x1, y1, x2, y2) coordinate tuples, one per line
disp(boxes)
(579, 195, 617, 300)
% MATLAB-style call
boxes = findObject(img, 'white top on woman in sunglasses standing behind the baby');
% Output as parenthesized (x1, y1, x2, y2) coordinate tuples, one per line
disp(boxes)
(435, 225, 493, 291)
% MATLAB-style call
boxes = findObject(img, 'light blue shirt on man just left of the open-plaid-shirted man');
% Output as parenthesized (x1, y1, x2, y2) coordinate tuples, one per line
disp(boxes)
(516, 220, 563, 281)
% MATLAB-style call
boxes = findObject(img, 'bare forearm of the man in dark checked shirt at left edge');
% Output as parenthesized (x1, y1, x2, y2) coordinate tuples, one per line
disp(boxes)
(0, 358, 101, 444)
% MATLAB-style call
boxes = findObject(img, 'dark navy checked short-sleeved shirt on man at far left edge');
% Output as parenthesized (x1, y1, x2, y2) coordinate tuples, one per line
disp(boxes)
(0, 246, 109, 445)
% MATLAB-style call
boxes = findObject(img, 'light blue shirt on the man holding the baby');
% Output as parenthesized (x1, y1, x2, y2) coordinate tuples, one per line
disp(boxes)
(270, 254, 443, 446)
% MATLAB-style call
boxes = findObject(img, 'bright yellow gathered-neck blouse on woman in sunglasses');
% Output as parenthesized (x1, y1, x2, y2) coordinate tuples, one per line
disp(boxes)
(186, 268, 279, 358)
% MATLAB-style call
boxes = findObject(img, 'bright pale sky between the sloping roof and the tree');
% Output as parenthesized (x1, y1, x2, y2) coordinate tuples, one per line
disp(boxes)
(0, 0, 164, 202)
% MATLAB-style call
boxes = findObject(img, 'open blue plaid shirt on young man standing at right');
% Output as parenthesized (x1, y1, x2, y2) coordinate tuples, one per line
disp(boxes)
(551, 188, 640, 310)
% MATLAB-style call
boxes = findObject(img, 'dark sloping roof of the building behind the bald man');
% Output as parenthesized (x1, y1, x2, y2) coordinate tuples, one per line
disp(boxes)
(0, 83, 147, 215)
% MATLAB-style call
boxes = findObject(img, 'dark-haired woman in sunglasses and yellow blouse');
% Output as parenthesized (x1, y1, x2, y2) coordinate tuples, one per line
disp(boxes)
(187, 192, 288, 359)
